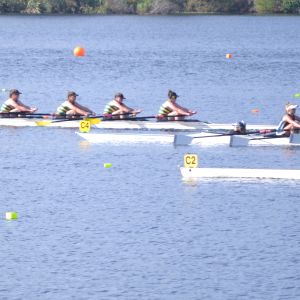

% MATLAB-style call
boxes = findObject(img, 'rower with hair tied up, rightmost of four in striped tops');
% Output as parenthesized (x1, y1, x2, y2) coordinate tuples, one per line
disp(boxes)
(158, 91, 197, 121)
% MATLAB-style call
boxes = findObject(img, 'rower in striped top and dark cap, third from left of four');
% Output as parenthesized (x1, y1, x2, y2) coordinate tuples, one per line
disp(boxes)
(103, 93, 142, 119)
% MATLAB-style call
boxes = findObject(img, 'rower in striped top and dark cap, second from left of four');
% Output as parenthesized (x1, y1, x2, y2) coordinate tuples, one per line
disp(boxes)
(55, 92, 95, 116)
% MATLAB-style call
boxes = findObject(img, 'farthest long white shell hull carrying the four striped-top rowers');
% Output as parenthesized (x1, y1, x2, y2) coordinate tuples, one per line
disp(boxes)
(0, 118, 276, 131)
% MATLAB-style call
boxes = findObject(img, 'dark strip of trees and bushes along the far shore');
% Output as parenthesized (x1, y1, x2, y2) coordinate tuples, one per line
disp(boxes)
(0, 0, 300, 14)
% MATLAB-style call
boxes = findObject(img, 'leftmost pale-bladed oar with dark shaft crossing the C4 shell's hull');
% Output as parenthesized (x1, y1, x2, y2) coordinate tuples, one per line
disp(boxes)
(174, 129, 276, 146)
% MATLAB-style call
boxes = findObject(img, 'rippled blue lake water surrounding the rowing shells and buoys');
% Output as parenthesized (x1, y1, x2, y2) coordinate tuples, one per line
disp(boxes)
(0, 16, 300, 300)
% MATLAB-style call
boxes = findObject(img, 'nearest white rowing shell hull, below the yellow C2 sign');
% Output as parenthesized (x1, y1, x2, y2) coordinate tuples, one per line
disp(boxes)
(180, 167, 300, 180)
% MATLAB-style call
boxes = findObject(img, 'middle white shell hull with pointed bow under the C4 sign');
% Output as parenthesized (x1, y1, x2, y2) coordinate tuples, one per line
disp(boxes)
(76, 132, 300, 147)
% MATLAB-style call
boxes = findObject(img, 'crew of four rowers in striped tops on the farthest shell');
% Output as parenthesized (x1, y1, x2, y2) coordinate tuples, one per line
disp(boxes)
(0, 89, 197, 120)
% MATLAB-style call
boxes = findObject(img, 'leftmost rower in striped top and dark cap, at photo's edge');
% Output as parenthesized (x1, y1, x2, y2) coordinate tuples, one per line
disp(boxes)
(0, 89, 37, 113)
